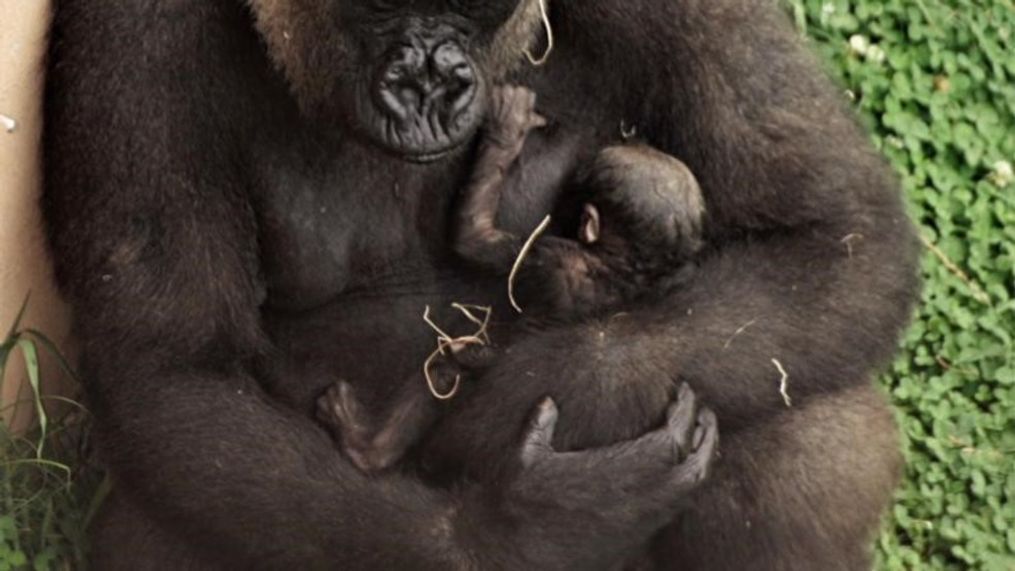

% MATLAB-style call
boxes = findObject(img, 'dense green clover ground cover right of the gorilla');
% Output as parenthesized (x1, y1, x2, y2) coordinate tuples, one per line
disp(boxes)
(787, 0, 1015, 571)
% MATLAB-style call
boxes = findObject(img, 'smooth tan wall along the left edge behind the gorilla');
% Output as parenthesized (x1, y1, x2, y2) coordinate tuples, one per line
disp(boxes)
(0, 0, 71, 427)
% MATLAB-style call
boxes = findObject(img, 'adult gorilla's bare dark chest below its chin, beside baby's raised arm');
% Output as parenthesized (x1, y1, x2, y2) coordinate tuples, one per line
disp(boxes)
(254, 127, 592, 311)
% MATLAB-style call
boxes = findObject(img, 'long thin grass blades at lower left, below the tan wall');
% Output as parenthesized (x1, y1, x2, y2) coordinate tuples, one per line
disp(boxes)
(0, 300, 104, 571)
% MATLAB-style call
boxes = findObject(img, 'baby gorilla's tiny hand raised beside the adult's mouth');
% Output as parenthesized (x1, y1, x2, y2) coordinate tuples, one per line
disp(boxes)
(486, 85, 546, 161)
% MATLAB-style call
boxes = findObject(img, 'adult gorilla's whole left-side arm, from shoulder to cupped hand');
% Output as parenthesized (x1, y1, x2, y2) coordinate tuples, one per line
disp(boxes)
(45, 0, 711, 569)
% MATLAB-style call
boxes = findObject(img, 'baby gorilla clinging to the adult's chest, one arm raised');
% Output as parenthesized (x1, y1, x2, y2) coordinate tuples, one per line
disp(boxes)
(318, 86, 714, 472)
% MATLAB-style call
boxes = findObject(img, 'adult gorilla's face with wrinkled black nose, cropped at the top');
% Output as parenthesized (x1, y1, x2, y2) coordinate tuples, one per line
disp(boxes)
(252, 0, 539, 162)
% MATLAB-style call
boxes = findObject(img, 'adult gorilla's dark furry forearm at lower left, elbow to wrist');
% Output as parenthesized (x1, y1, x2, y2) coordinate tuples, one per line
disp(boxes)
(90, 369, 467, 569)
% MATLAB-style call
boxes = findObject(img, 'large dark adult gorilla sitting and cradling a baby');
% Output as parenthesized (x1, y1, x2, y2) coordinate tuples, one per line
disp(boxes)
(45, 0, 916, 569)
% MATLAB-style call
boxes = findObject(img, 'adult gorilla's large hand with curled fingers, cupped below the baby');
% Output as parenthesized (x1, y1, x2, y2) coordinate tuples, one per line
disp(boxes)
(477, 384, 719, 569)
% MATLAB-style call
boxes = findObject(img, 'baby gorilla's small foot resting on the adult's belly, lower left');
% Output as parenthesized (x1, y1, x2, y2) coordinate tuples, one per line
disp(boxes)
(317, 380, 399, 473)
